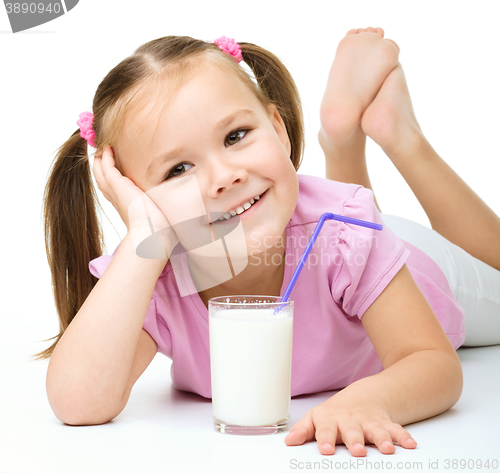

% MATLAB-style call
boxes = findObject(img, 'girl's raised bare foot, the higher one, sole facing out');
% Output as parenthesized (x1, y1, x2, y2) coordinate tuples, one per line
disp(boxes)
(319, 28, 399, 148)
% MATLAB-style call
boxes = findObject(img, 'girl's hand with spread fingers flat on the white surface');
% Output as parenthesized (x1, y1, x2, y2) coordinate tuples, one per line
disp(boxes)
(285, 389, 417, 457)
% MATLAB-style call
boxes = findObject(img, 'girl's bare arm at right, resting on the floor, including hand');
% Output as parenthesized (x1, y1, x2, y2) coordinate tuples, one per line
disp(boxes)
(285, 265, 462, 456)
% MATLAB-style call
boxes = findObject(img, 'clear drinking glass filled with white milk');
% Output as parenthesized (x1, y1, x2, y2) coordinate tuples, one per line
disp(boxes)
(208, 296, 293, 435)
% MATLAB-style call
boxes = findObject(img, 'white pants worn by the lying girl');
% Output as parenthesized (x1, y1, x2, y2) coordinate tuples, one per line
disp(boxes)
(382, 214, 500, 346)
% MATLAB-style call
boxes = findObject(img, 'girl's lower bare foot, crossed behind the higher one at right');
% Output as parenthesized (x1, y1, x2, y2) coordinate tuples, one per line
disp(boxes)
(361, 64, 425, 161)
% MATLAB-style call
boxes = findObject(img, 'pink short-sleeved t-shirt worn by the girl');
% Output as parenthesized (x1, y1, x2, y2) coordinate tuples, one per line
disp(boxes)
(89, 175, 465, 398)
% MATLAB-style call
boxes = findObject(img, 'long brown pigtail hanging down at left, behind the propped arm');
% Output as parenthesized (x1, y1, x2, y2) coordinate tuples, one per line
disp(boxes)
(35, 130, 104, 359)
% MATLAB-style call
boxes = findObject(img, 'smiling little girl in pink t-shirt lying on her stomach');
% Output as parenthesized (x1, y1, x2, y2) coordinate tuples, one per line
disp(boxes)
(40, 28, 500, 456)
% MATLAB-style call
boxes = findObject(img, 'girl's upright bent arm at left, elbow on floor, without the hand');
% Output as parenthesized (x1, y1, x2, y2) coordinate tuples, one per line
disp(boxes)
(47, 235, 165, 424)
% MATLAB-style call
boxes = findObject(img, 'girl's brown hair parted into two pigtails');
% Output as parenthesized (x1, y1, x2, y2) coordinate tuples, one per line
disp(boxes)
(35, 36, 304, 359)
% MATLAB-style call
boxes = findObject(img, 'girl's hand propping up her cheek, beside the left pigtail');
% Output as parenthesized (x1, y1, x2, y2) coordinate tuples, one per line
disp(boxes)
(94, 146, 175, 254)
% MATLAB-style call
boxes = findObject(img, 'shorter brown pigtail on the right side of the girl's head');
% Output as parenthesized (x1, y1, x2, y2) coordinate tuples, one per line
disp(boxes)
(238, 43, 304, 170)
